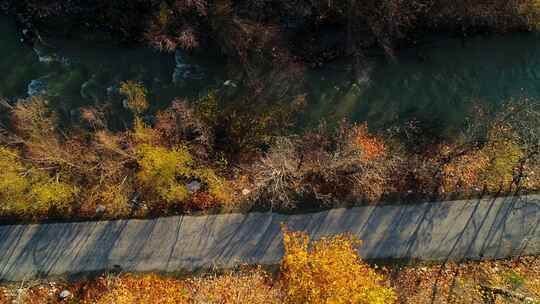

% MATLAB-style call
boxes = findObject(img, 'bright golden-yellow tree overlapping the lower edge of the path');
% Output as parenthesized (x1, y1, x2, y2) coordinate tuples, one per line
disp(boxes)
(281, 231, 396, 304)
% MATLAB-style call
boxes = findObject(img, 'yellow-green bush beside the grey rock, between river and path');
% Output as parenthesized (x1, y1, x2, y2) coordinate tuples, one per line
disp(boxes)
(137, 145, 193, 203)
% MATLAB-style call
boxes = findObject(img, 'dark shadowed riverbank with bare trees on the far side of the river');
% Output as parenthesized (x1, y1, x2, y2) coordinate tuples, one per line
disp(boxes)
(0, 0, 540, 64)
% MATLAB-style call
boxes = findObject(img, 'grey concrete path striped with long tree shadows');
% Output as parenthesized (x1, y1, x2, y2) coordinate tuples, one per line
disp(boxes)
(0, 195, 540, 281)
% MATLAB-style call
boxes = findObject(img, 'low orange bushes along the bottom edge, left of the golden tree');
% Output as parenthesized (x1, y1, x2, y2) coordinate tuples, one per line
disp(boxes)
(80, 269, 282, 304)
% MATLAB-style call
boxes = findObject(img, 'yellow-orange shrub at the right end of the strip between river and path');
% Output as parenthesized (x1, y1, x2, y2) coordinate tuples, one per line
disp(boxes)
(456, 99, 540, 192)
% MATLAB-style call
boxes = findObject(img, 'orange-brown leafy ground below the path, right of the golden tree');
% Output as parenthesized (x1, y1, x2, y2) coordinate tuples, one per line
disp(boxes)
(389, 257, 540, 304)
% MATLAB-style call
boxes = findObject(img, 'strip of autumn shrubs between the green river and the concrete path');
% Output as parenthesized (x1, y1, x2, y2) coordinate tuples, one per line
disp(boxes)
(0, 90, 540, 221)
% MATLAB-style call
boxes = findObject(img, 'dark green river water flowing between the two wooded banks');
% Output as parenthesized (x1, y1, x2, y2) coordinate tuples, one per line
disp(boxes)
(0, 17, 540, 133)
